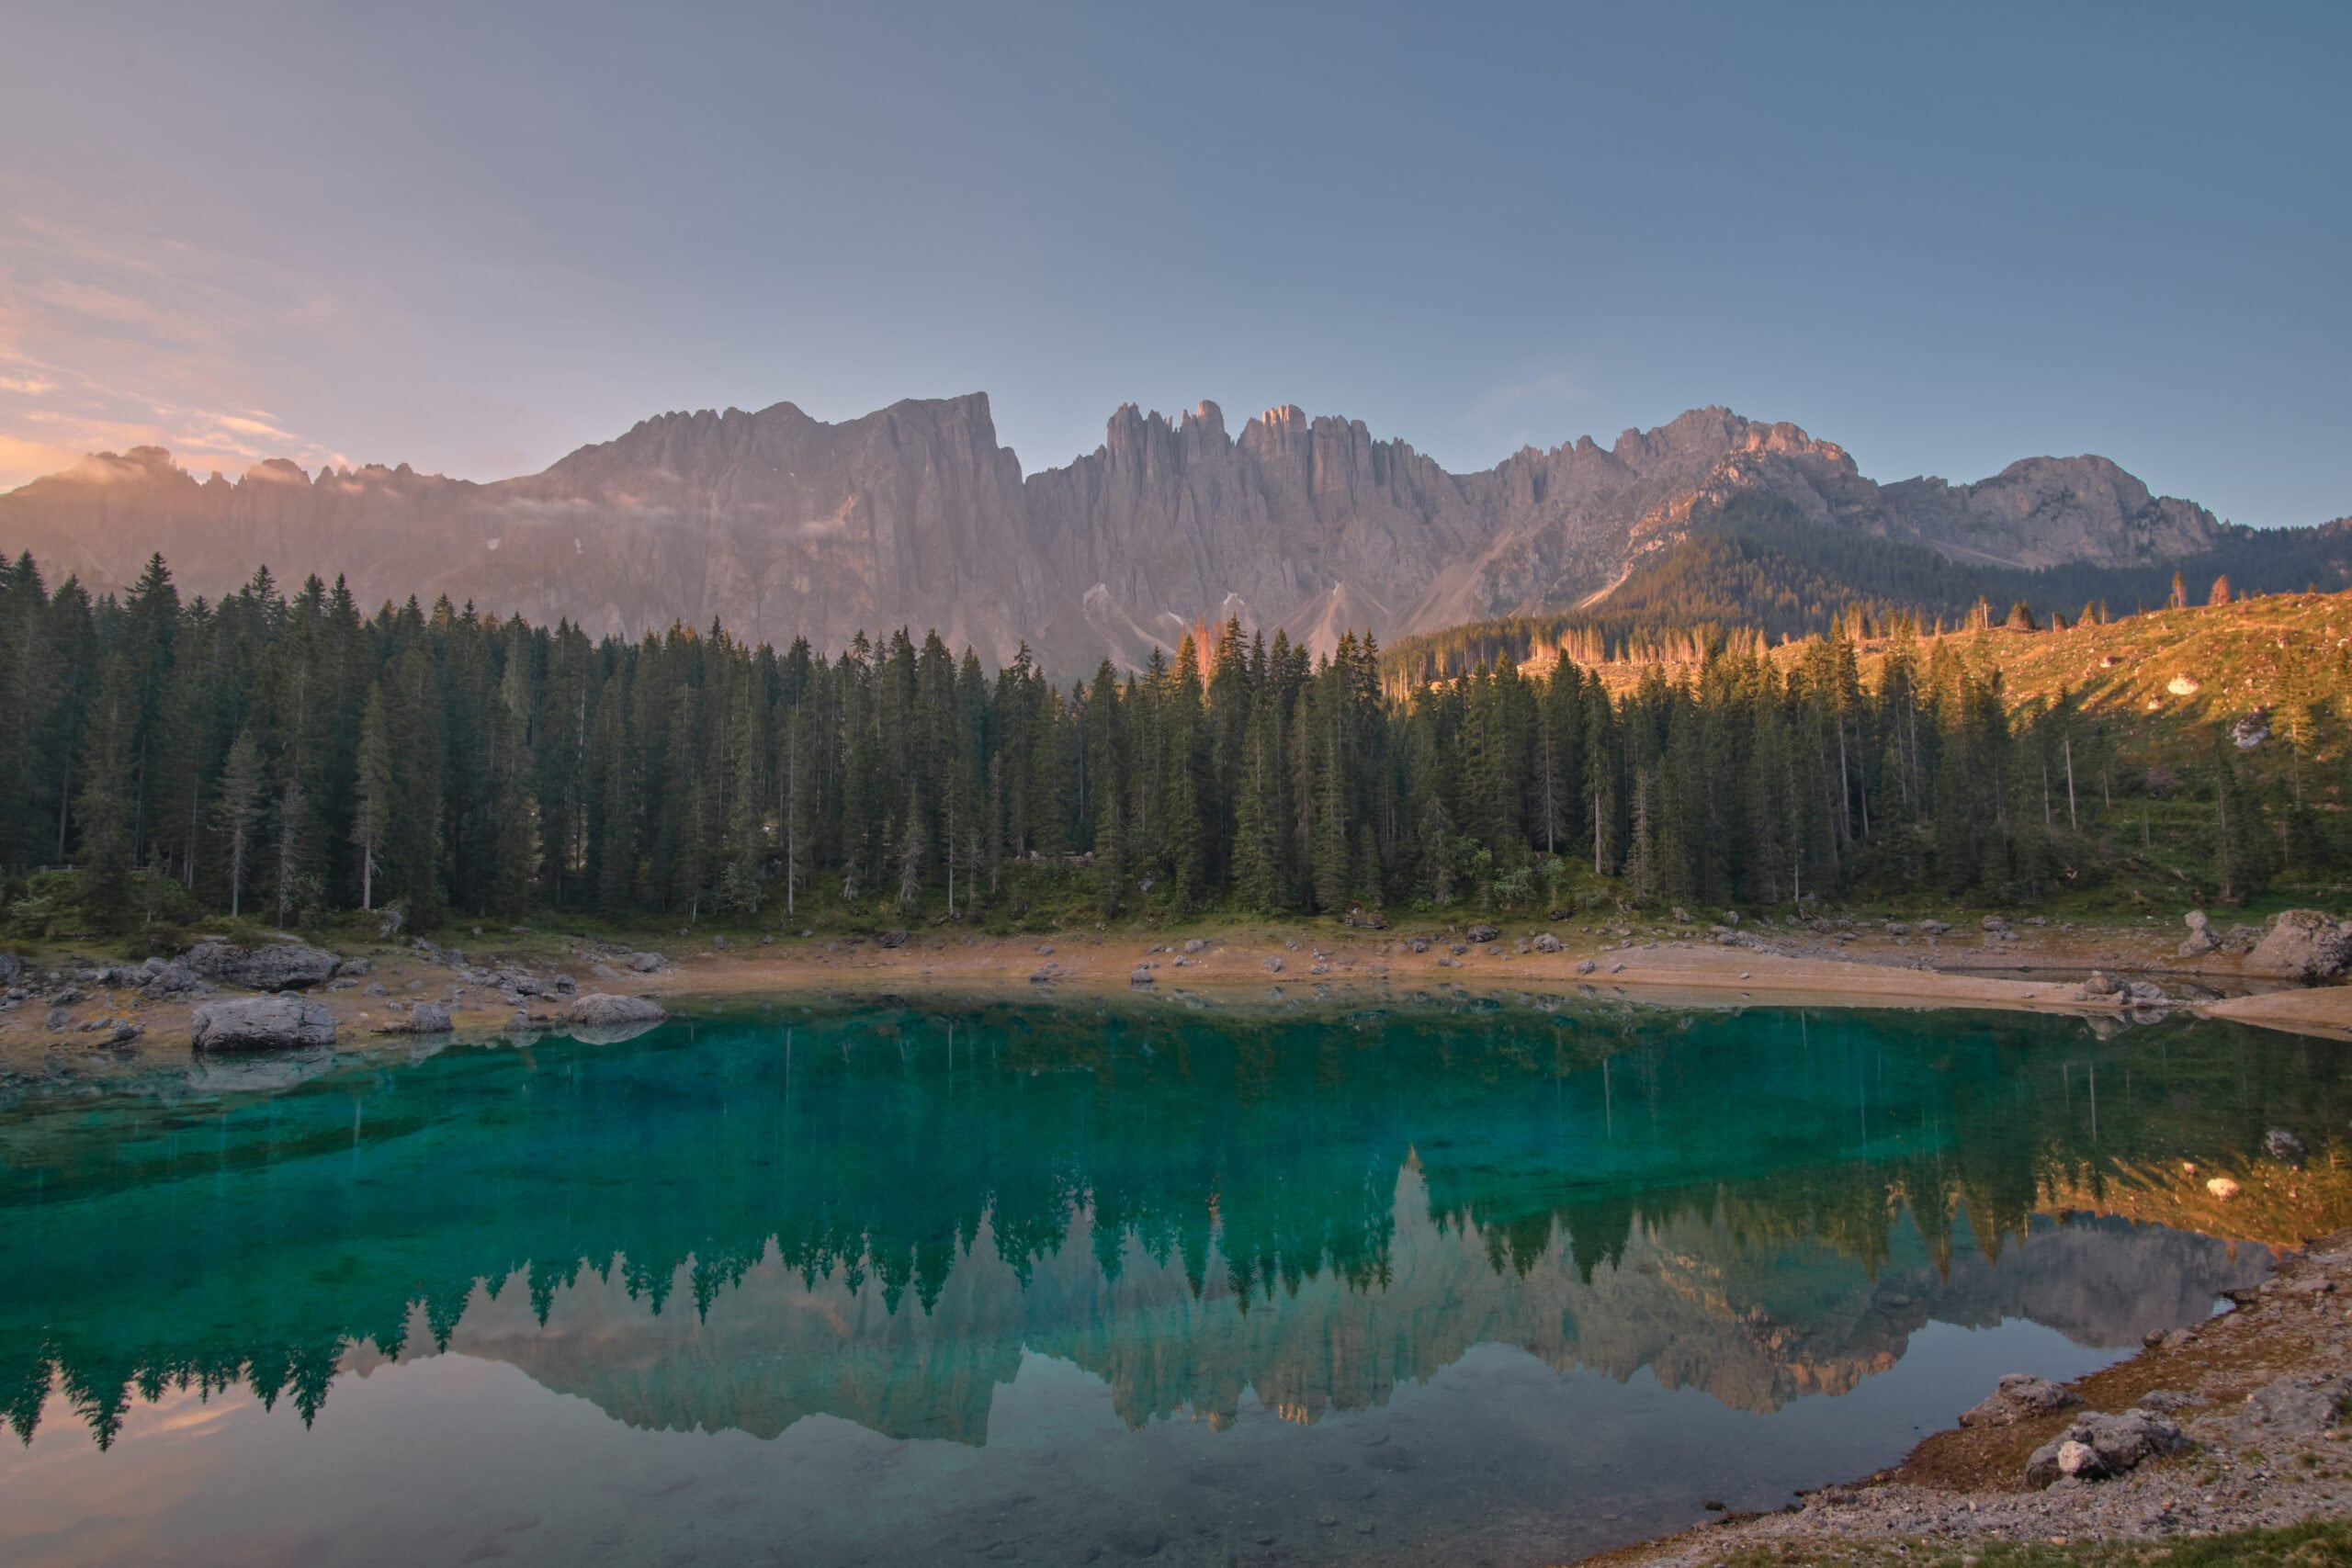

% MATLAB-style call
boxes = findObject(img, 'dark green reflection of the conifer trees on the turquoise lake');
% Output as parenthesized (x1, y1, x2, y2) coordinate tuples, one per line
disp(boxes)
(0, 1009, 2352, 1441)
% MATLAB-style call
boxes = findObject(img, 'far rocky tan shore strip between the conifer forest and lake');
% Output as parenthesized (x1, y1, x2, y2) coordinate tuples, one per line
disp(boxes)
(0, 909, 2352, 1090)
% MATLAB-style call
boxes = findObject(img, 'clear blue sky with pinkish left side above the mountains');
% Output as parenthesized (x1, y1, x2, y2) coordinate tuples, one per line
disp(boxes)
(0, 0, 2352, 525)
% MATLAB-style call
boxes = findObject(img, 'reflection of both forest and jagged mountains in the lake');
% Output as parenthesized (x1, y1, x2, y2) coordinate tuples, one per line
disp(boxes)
(0, 1006, 2352, 1443)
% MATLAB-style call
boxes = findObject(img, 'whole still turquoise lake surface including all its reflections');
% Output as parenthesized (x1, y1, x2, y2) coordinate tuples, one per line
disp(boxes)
(0, 1006, 2352, 1563)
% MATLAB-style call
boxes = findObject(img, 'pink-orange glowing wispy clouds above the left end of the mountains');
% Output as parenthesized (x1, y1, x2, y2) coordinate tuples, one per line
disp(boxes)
(0, 176, 348, 489)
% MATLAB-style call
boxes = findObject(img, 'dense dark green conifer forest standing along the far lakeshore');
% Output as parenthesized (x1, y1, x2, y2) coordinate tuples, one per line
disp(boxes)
(0, 559, 2340, 936)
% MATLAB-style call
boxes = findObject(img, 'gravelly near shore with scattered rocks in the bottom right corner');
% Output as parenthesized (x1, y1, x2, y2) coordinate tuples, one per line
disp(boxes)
(1583, 1232, 2352, 1568)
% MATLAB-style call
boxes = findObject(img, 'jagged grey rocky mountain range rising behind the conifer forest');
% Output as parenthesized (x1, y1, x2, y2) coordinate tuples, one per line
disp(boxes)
(0, 392, 2295, 672)
